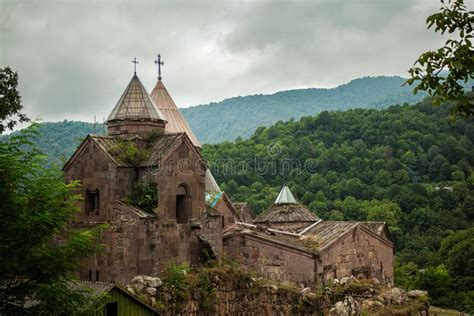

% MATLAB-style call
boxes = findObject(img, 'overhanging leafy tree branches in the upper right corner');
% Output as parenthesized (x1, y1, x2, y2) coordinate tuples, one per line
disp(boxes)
(406, 0, 474, 116)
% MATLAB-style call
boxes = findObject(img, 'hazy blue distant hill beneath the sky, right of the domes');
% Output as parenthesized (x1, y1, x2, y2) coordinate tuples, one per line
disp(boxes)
(181, 76, 426, 144)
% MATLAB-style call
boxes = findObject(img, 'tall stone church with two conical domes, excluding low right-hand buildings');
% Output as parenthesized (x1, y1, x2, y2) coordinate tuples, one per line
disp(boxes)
(63, 75, 231, 284)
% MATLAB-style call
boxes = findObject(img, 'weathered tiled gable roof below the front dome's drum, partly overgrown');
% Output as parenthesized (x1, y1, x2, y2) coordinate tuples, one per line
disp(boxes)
(91, 133, 184, 167)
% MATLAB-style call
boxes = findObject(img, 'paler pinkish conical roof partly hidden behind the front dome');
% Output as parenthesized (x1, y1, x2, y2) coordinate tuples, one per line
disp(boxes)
(151, 80, 201, 147)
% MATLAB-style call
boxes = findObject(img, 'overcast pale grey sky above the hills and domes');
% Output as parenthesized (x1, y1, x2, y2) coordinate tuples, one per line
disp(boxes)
(0, 0, 443, 121)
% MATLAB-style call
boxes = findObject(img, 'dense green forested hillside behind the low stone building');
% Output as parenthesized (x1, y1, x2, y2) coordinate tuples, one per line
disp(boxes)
(203, 101, 474, 310)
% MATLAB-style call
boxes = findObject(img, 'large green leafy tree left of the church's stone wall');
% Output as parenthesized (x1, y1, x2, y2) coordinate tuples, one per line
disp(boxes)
(0, 127, 100, 315)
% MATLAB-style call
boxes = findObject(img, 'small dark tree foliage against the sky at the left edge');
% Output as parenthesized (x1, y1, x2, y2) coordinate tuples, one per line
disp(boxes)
(0, 67, 29, 134)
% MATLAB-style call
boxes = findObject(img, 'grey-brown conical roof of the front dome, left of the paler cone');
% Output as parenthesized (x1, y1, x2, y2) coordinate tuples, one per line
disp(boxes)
(107, 74, 166, 122)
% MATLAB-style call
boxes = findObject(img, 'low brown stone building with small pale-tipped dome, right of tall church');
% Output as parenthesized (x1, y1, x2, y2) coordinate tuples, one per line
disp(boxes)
(224, 187, 394, 286)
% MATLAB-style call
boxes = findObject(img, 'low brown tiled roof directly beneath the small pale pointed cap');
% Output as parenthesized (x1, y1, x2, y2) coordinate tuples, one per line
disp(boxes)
(254, 203, 318, 223)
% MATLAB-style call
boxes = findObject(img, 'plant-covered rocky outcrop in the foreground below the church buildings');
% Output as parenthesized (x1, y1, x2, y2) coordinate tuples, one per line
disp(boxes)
(126, 266, 428, 316)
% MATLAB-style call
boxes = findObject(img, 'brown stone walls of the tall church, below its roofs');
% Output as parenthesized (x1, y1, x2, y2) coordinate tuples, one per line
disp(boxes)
(69, 139, 210, 284)
